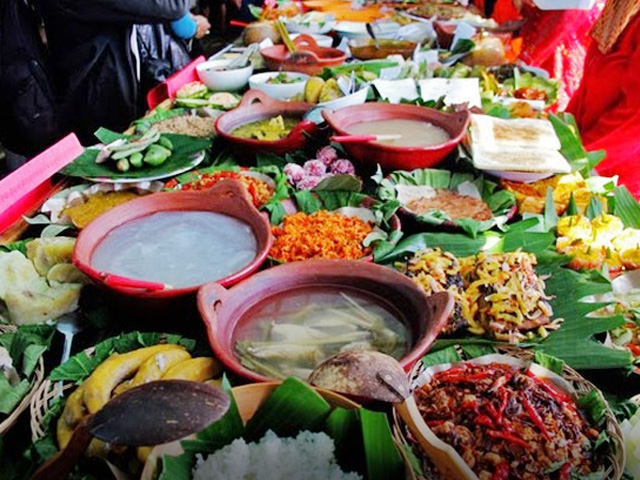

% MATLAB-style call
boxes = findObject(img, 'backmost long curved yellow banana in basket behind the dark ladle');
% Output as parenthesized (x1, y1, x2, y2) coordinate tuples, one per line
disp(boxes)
(83, 344, 183, 413)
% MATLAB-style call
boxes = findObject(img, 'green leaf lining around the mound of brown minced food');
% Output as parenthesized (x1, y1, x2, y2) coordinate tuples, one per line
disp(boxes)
(378, 169, 516, 237)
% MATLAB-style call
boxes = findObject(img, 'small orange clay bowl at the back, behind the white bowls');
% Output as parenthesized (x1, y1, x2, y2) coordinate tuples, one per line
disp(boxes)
(260, 34, 347, 75)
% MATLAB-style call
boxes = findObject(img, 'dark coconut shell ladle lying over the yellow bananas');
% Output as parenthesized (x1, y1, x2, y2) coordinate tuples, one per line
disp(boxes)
(31, 380, 230, 480)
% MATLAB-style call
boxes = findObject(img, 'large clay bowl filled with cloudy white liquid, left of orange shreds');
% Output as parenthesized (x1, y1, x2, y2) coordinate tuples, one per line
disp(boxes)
(73, 179, 273, 303)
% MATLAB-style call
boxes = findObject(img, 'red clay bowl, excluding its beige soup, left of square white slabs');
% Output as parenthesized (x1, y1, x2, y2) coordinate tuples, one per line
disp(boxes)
(322, 102, 469, 170)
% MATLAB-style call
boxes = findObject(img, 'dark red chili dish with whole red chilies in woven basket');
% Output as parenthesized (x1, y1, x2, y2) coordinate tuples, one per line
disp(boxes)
(414, 363, 599, 480)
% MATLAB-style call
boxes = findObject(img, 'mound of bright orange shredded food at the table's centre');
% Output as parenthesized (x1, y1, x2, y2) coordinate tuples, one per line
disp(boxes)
(269, 210, 373, 262)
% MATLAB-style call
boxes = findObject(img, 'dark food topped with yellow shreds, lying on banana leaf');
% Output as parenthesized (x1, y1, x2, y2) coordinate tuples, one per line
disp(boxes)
(400, 248, 559, 343)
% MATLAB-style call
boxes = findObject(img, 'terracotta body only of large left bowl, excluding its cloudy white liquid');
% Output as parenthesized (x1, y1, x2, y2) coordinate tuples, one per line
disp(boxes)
(73, 179, 273, 304)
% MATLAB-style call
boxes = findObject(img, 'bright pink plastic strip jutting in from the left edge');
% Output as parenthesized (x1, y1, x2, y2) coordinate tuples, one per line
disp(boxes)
(0, 133, 84, 233)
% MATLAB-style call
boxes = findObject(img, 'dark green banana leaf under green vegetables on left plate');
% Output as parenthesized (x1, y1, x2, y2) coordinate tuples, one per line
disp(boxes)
(60, 129, 211, 179)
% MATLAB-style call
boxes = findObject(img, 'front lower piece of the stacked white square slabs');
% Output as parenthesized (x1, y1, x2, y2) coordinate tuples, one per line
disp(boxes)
(473, 146, 571, 173)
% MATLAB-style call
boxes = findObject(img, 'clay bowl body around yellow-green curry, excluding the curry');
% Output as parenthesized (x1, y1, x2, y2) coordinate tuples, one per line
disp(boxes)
(215, 89, 318, 158)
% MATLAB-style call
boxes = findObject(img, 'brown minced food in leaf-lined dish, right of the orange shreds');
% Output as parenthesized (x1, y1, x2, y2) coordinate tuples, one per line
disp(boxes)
(405, 189, 493, 221)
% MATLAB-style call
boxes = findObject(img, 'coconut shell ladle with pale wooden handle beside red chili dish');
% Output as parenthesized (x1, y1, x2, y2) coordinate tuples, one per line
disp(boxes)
(309, 350, 478, 480)
